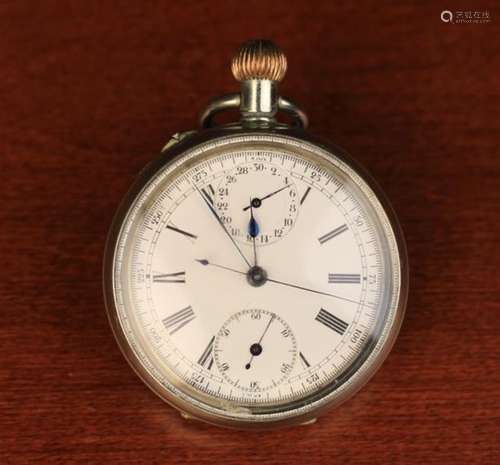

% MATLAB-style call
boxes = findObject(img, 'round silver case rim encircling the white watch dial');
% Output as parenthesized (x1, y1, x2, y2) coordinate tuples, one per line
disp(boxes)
(103, 126, 409, 429)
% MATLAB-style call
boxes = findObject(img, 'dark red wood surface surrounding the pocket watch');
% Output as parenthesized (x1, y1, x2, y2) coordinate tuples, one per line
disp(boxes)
(0, 0, 500, 465)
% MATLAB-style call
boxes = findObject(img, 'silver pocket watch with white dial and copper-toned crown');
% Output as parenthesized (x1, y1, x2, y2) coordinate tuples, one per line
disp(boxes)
(104, 40, 408, 428)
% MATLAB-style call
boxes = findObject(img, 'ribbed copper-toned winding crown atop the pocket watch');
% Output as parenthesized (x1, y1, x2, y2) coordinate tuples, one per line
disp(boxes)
(231, 40, 287, 81)
